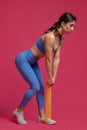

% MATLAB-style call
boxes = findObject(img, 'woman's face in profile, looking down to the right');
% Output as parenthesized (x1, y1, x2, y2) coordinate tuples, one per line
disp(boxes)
(61, 21, 75, 33)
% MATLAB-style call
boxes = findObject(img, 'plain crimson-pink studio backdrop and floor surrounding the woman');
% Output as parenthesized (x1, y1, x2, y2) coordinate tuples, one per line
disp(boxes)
(0, 0, 87, 130)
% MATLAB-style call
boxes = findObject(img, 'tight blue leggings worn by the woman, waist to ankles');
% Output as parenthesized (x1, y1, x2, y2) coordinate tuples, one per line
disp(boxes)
(15, 50, 44, 110)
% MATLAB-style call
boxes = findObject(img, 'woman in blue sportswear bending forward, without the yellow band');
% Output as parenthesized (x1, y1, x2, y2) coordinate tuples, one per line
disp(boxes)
(13, 13, 76, 125)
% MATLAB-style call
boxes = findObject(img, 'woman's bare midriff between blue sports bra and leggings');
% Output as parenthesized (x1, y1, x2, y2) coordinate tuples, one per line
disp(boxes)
(30, 36, 45, 58)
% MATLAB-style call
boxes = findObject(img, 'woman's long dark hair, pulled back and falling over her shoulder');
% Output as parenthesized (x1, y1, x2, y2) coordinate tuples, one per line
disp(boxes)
(44, 12, 76, 33)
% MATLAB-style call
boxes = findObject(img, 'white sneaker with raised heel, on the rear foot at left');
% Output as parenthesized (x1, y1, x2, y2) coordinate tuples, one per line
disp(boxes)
(13, 108, 27, 125)
